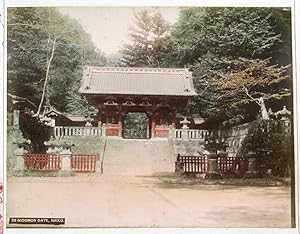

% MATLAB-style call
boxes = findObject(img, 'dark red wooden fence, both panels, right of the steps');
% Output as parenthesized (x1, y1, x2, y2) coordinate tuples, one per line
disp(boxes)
(175, 155, 248, 174)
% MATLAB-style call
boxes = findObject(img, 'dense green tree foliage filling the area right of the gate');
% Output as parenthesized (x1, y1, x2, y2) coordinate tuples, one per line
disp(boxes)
(169, 8, 291, 118)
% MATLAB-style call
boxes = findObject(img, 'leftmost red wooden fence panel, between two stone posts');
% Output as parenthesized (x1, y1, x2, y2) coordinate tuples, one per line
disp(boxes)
(25, 154, 61, 171)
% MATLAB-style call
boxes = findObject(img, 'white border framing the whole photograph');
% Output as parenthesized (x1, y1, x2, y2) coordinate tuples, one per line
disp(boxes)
(0, 0, 300, 234)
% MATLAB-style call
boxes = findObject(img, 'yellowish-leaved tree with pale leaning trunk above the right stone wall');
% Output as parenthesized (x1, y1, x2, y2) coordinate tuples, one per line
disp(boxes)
(213, 58, 291, 119)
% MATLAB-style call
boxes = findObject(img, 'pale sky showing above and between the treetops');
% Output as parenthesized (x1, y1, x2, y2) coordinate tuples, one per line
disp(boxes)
(58, 7, 179, 55)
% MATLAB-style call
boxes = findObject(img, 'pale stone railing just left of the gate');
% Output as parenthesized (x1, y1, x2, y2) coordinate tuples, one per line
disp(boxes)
(54, 126, 105, 138)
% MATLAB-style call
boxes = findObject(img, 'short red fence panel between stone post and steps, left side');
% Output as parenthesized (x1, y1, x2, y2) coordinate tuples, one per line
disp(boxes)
(71, 154, 100, 172)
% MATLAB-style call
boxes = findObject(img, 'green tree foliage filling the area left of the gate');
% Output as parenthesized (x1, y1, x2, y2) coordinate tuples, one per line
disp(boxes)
(7, 8, 106, 115)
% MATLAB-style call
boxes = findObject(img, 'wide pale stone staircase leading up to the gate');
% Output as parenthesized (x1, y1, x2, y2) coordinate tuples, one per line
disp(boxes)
(103, 137, 175, 175)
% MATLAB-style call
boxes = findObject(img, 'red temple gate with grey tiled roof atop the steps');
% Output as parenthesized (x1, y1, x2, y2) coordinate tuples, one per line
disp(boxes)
(79, 66, 196, 138)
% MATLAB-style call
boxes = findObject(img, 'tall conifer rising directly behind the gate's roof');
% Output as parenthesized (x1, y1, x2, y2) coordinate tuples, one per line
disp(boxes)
(120, 10, 170, 67)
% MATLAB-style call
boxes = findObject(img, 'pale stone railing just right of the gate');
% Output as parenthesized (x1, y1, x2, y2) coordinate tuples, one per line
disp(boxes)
(169, 129, 210, 139)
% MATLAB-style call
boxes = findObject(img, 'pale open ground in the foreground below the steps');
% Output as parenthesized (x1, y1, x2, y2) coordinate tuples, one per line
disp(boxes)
(7, 175, 291, 227)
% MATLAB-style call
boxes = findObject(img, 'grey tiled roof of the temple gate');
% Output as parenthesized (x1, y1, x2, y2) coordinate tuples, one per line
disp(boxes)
(79, 66, 196, 96)
